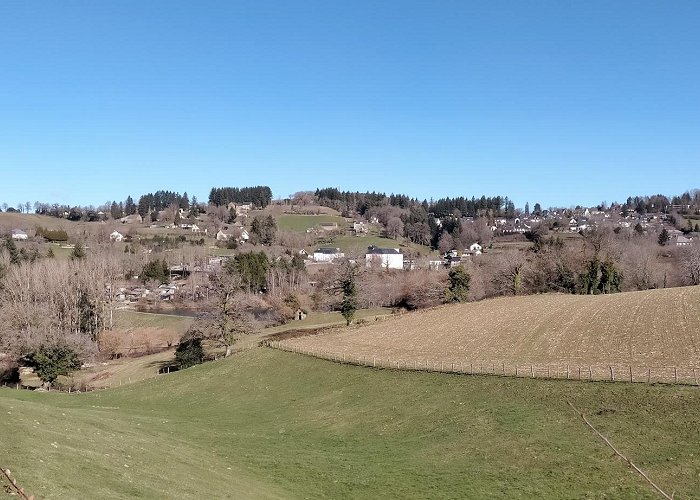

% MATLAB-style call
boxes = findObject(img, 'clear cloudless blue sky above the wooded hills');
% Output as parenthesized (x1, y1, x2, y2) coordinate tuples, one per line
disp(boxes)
(0, 0, 700, 206)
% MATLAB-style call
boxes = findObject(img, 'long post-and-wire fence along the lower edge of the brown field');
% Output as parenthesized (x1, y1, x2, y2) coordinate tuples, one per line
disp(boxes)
(266, 340, 700, 386)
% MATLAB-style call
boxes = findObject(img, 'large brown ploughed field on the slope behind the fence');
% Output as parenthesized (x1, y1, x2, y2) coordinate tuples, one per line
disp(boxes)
(287, 287, 700, 374)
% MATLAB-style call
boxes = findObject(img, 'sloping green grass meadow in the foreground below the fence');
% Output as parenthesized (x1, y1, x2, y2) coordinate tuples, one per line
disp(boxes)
(0, 348, 700, 499)
